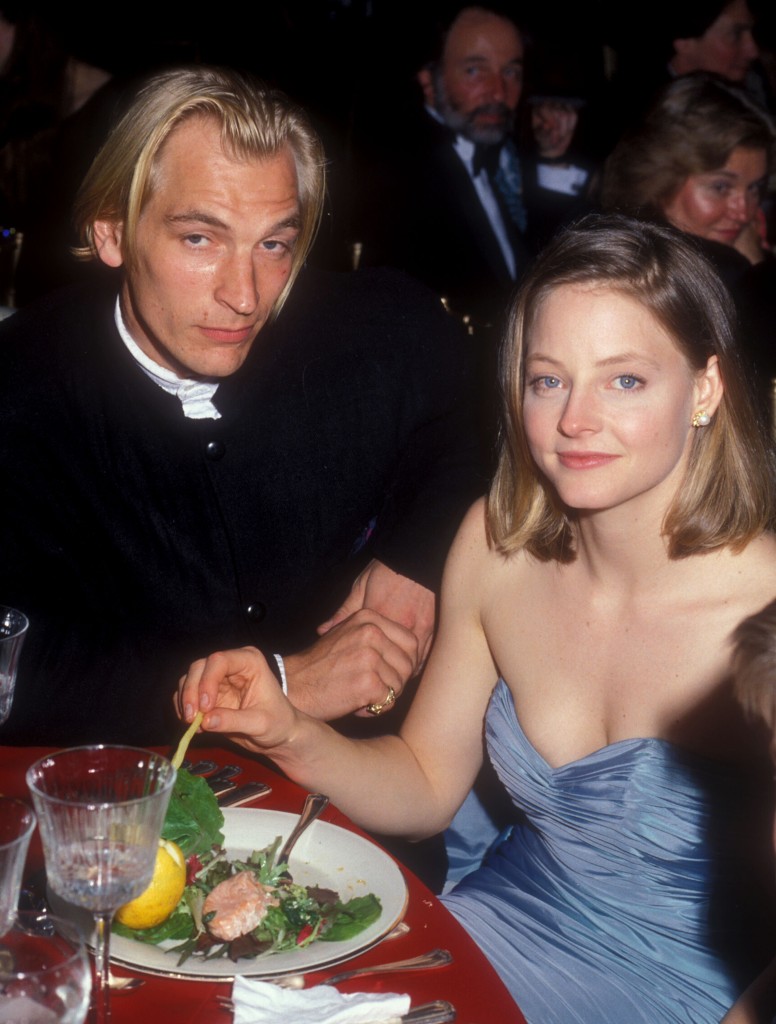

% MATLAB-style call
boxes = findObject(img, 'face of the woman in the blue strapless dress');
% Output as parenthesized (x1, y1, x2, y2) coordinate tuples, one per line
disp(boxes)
(523, 285, 721, 515)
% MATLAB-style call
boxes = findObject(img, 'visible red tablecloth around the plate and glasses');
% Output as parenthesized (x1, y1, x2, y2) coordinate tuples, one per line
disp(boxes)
(0, 744, 525, 1024)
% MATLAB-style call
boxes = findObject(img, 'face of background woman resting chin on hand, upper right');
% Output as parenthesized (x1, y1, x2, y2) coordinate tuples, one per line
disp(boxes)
(663, 146, 768, 246)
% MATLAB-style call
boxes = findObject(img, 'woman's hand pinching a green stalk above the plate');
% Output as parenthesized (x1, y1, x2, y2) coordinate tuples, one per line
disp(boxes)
(176, 647, 299, 752)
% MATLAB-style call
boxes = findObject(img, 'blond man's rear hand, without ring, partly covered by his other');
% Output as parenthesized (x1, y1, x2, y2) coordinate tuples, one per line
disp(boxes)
(318, 559, 436, 671)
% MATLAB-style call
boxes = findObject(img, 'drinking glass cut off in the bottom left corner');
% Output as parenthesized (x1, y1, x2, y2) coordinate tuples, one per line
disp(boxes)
(0, 913, 91, 1024)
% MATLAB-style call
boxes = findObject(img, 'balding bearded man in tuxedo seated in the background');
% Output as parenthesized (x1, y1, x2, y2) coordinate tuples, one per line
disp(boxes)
(359, 6, 529, 333)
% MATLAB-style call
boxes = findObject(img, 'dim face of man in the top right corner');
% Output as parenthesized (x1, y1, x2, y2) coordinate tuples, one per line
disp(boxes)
(673, 0, 758, 82)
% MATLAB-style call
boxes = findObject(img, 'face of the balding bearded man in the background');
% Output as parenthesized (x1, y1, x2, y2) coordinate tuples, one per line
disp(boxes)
(421, 8, 523, 145)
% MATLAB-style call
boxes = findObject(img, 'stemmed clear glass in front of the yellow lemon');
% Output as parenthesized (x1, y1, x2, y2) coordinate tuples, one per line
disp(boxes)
(27, 745, 175, 1024)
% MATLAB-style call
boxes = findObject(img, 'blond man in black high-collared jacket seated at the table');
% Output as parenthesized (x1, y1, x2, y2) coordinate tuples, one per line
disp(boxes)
(0, 68, 478, 774)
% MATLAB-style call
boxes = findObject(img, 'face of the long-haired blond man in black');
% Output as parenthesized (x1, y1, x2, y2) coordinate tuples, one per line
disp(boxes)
(94, 118, 299, 378)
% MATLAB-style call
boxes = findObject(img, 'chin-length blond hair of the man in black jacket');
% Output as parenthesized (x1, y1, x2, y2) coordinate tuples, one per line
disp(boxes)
(75, 67, 325, 312)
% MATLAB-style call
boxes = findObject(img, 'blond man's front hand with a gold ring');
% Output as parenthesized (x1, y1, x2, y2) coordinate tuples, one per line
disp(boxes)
(284, 608, 419, 721)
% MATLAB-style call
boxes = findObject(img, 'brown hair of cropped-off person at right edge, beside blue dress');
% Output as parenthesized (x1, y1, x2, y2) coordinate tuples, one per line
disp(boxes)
(732, 601, 776, 729)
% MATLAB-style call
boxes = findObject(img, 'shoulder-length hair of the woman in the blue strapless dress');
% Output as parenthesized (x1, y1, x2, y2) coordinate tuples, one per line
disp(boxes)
(487, 215, 775, 561)
